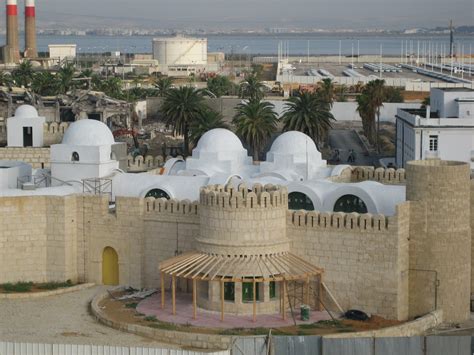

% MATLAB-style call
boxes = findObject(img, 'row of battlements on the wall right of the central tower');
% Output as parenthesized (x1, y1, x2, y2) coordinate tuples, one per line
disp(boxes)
(287, 211, 389, 231)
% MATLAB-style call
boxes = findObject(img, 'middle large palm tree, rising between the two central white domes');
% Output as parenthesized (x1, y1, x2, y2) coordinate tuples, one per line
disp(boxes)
(232, 99, 278, 160)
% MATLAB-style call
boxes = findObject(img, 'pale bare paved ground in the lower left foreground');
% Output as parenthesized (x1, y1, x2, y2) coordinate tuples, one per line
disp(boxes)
(0, 287, 173, 348)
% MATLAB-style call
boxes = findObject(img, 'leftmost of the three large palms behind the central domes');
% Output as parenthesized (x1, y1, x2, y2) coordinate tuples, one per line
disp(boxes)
(161, 86, 206, 156)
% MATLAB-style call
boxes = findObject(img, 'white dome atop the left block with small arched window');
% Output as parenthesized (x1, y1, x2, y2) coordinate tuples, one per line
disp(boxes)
(62, 119, 115, 146)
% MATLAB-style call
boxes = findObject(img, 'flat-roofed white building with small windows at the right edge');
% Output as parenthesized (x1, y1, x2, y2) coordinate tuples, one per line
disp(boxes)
(396, 88, 474, 169)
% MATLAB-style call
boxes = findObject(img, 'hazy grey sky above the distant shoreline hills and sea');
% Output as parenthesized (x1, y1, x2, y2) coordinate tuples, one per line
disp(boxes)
(30, 0, 474, 28)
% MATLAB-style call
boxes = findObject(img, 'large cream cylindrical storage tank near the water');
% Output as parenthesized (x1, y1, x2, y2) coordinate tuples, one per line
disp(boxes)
(153, 36, 207, 66)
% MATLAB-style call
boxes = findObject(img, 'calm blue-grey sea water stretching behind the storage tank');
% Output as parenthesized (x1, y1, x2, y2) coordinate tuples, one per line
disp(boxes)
(0, 34, 474, 55)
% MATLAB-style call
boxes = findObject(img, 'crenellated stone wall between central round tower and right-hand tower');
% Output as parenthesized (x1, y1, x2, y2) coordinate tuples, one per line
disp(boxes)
(287, 205, 409, 320)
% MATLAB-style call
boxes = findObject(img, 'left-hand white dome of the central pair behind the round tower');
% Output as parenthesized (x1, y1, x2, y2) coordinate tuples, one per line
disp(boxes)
(195, 128, 244, 153)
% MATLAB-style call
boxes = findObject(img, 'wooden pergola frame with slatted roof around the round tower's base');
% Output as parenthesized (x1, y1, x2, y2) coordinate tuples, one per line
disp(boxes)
(160, 251, 324, 322)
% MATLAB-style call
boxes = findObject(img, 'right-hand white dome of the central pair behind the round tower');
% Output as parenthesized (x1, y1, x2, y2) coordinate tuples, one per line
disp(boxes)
(270, 131, 320, 155)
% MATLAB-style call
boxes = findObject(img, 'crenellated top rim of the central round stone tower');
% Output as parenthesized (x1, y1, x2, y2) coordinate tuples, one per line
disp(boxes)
(200, 184, 288, 208)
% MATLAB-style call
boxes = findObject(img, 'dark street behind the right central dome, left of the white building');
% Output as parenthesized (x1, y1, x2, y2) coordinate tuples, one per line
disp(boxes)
(329, 129, 374, 166)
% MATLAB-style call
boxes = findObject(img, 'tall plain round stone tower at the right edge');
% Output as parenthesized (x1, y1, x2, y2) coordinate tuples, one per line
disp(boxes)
(406, 160, 471, 322)
